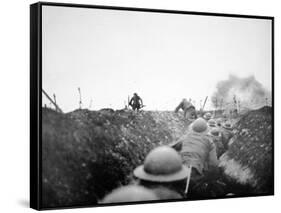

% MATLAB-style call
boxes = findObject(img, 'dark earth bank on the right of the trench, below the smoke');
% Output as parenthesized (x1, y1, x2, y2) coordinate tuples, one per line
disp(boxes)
(220, 107, 273, 195)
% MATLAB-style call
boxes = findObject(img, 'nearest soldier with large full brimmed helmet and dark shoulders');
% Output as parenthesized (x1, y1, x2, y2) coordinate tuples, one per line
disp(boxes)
(133, 146, 188, 199)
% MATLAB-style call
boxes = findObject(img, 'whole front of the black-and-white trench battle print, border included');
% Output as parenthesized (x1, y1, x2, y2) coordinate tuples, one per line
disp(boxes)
(30, 3, 274, 209)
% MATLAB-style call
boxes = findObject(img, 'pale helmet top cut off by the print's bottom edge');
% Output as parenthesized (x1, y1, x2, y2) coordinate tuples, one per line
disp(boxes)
(100, 185, 159, 203)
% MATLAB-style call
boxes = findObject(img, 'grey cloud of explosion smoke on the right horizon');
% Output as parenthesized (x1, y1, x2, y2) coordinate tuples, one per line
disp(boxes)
(211, 75, 271, 110)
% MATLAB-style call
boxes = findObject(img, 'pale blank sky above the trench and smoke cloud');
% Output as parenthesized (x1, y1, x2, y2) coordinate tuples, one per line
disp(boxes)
(42, 6, 271, 112)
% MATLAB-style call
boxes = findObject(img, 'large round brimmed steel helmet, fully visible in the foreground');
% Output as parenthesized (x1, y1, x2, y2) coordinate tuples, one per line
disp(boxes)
(134, 146, 188, 182)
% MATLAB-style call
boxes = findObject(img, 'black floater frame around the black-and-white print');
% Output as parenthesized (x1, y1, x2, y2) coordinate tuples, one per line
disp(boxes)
(30, 2, 274, 210)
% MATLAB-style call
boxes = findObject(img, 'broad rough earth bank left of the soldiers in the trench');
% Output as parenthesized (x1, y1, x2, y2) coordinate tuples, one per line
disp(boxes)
(42, 109, 189, 207)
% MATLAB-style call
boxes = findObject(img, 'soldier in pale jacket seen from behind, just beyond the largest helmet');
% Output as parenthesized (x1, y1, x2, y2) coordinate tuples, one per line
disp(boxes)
(172, 118, 225, 199)
